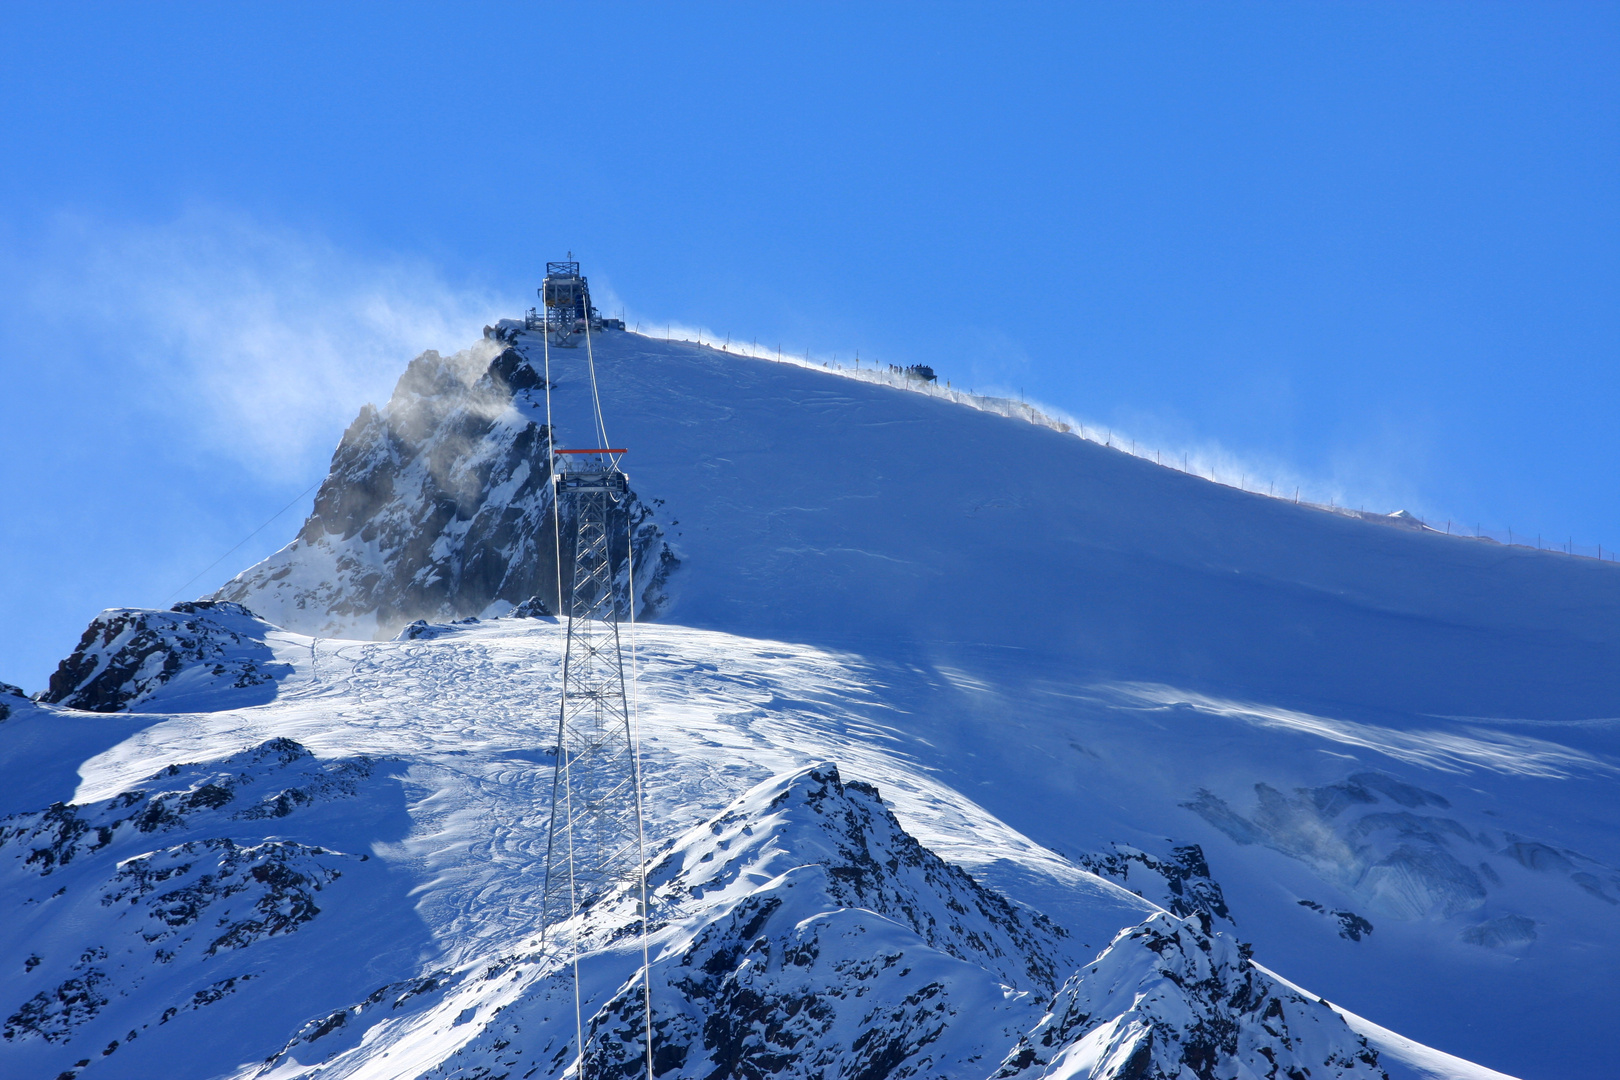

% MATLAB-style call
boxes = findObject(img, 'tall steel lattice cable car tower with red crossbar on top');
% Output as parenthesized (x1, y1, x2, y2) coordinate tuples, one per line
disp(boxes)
(544, 452, 642, 929)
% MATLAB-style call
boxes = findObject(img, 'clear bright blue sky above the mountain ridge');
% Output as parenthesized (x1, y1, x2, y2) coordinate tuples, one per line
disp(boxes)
(0, 0, 1620, 690)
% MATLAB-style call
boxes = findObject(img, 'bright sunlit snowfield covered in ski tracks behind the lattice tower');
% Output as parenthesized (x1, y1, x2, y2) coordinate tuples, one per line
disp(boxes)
(73, 622, 1140, 962)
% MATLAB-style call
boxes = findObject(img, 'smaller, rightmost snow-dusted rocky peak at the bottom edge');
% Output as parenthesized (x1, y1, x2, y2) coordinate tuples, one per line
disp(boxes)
(995, 913, 1385, 1080)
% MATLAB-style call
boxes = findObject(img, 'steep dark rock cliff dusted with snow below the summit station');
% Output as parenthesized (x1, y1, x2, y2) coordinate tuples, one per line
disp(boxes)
(214, 338, 676, 638)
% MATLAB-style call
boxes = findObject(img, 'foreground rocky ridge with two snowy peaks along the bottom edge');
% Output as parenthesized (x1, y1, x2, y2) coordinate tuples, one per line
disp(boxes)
(285, 764, 1383, 1080)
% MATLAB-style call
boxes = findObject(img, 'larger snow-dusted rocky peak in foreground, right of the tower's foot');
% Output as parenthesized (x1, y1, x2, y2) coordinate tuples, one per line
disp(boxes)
(417, 764, 1072, 1077)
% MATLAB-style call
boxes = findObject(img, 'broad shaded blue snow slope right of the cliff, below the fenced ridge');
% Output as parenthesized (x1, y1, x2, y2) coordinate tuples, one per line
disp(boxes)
(463, 335, 1620, 1075)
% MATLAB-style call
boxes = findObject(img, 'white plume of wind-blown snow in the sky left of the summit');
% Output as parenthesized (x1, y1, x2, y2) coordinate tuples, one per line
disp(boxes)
(19, 210, 496, 476)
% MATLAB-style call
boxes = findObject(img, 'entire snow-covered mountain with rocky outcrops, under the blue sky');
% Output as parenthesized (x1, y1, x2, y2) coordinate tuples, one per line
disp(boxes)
(9, 329, 1620, 1080)
